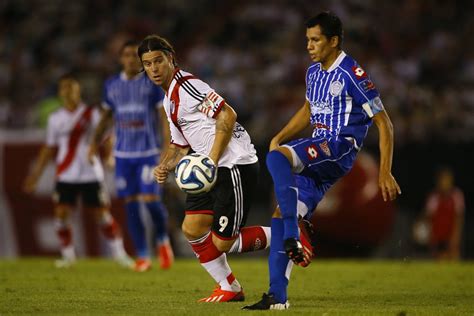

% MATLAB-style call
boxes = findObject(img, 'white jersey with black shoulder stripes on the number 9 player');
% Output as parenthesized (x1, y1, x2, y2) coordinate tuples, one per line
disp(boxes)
(163, 69, 258, 168)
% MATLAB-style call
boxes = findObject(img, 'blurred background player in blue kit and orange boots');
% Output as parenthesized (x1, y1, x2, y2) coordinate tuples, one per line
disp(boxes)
(90, 41, 174, 272)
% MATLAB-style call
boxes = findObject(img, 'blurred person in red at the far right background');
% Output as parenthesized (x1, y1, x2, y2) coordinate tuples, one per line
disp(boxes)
(425, 168, 465, 260)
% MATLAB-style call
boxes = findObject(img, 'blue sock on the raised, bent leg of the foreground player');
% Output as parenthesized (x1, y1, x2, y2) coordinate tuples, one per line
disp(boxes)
(267, 150, 299, 240)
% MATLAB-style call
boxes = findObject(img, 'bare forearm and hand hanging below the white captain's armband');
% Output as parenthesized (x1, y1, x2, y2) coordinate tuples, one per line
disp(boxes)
(373, 110, 402, 201)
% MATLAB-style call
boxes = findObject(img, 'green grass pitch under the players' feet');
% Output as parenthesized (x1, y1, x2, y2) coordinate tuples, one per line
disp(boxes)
(0, 257, 474, 316)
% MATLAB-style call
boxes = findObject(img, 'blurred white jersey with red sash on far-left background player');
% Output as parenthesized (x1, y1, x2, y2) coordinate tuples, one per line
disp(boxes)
(46, 104, 104, 183)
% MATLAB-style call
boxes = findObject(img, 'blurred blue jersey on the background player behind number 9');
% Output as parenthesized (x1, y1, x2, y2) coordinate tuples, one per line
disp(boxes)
(103, 72, 164, 158)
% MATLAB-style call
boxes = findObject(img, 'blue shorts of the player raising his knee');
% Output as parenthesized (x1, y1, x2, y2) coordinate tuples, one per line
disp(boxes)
(283, 137, 357, 217)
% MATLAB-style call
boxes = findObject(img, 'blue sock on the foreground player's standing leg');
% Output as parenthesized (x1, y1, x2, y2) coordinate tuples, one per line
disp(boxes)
(268, 218, 293, 303)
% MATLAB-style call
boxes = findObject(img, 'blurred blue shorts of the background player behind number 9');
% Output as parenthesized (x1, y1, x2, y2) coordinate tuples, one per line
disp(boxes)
(115, 156, 162, 198)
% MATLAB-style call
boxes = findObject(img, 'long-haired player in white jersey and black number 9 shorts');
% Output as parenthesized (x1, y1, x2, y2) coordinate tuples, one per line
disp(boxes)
(138, 35, 270, 302)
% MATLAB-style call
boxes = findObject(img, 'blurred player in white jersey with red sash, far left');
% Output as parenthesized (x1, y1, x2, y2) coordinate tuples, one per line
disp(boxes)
(24, 75, 133, 267)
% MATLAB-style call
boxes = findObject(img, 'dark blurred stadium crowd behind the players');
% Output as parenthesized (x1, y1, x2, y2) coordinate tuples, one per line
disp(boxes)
(0, 0, 474, 146)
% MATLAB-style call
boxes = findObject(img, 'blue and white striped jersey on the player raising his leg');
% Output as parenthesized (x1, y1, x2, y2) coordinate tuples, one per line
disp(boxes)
(306, 52, 383, 148)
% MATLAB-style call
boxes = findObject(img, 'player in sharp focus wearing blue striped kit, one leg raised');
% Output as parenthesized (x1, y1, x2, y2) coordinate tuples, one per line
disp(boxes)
(244, 12, 401, 309)
